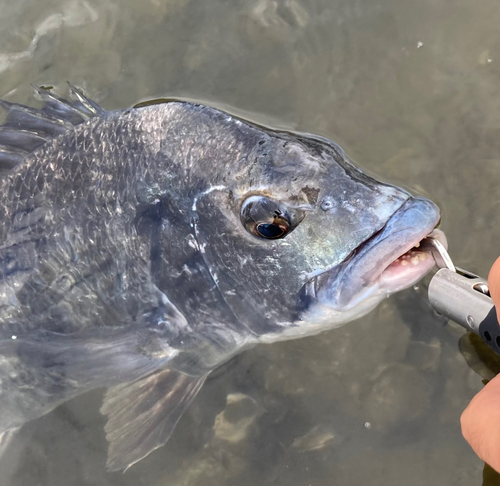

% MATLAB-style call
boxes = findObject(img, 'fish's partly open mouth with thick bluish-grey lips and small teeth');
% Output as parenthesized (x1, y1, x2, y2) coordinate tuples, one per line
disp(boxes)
(304, 197, 447, 312)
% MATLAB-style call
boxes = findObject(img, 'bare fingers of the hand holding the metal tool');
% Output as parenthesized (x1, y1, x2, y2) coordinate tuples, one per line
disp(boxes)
(460, 258, 500, 472)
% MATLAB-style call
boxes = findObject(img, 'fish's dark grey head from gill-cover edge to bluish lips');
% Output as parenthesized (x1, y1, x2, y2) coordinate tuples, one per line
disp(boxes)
(186, 110, 445, 342)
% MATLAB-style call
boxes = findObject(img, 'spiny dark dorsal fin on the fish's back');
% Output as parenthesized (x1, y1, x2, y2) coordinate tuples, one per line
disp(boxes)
(0, 84, 105, 174)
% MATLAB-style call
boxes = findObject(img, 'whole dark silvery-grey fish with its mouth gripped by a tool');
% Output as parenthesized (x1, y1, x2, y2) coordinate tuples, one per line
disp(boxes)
(0, 85, 446, 471)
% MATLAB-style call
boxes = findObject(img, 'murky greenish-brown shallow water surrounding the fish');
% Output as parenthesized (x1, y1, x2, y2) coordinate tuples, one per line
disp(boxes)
(0, 0, 500, 486)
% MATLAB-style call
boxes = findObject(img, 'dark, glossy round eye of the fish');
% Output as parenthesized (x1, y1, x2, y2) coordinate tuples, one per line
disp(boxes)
(241, 196, 294, 240)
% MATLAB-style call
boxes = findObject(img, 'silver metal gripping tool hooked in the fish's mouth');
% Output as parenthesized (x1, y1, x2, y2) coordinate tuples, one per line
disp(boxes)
(422, 237, 500, 355)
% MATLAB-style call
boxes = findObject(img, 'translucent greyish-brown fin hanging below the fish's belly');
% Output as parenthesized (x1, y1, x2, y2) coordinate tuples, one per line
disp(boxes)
(101, 370, 208, 471)
